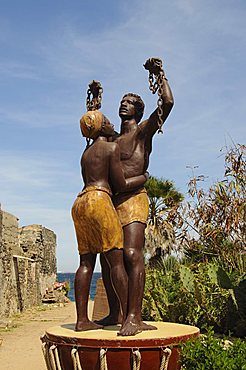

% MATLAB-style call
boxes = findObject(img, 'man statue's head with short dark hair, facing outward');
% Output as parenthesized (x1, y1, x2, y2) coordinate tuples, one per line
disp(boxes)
(119, 93, 144, 123)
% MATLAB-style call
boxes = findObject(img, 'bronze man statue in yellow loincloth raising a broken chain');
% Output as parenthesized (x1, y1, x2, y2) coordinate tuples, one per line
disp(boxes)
(98, 58, 174, 335)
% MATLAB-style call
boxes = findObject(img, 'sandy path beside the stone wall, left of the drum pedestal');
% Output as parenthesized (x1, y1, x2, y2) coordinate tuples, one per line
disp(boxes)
(0, 302, 93, 370)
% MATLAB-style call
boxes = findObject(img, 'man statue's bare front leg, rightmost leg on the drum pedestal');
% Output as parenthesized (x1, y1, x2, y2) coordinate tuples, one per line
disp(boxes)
(119, 222, 156, 335)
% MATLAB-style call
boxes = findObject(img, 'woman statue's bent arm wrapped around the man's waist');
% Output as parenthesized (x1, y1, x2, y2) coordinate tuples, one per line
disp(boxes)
(109, 143, 148, 193)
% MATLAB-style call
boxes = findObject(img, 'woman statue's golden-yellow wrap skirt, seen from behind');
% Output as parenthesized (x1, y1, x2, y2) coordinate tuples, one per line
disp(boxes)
(72, 186, 123, 254)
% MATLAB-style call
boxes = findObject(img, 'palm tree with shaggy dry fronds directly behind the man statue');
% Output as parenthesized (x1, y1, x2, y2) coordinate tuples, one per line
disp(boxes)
(145, 176, 184, 256)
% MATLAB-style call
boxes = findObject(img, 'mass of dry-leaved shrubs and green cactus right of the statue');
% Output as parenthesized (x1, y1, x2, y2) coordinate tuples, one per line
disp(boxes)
(143, 145, 246, 338)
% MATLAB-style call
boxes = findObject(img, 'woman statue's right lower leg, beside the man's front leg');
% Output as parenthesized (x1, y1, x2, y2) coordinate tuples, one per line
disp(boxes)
(104, 249, 128, 323)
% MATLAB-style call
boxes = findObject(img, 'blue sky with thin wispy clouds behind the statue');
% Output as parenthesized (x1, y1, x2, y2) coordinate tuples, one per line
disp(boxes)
(0, 0, 246, 271)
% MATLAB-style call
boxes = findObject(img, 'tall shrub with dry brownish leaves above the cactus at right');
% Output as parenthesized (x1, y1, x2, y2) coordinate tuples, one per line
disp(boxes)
(175, 144, 246, 275)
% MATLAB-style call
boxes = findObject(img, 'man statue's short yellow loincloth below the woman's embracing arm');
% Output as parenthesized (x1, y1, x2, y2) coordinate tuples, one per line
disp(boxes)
(113, 189, 149, 227)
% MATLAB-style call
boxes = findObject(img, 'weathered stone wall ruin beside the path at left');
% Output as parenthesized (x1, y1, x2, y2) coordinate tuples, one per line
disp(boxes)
(0, 210, 56, 317)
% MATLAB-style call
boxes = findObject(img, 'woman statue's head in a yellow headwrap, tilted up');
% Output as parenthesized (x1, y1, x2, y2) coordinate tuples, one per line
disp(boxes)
(80, 110, 114, 140)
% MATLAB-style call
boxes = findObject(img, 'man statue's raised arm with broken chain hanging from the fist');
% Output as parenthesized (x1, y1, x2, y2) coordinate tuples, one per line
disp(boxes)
(139, 58, 174, 137)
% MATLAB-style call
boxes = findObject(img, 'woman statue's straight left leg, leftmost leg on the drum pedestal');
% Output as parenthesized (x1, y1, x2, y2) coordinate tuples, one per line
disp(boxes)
(74, 253, 102, 331)
